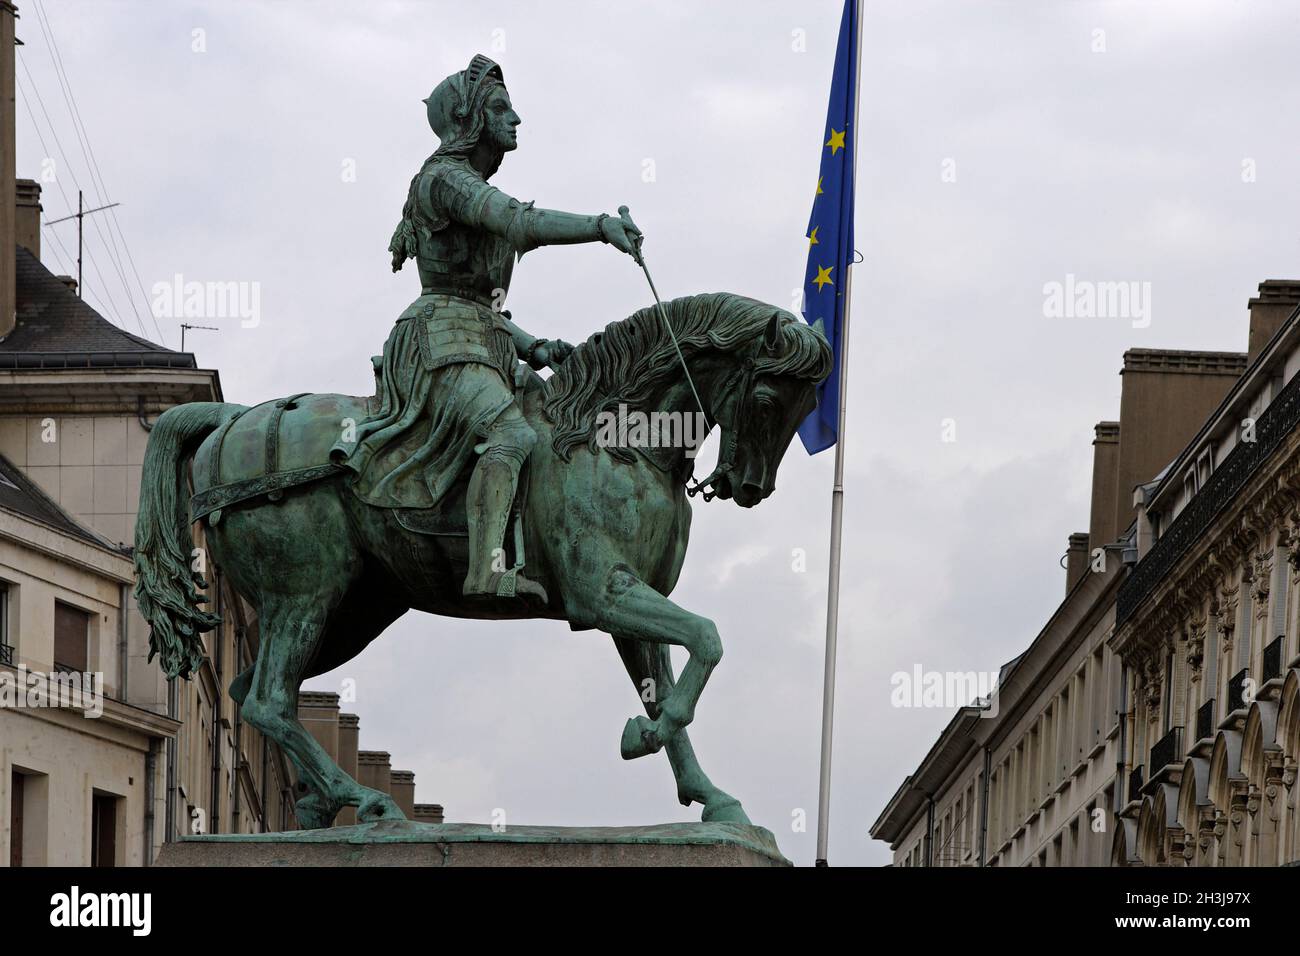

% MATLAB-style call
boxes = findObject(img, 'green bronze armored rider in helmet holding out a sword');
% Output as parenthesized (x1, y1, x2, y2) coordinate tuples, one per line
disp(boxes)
(335, 55, 641, 601)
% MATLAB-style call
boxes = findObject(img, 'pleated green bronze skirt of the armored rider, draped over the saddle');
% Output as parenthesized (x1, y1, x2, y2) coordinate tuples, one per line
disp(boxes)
(332, 294, 517, 509)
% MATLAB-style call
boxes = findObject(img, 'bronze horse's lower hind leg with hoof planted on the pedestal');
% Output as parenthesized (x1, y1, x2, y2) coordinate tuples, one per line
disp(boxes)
(242, 596, 404, 829)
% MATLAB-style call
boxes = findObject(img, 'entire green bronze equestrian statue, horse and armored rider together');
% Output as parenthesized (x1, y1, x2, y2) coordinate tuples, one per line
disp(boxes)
(135, 57, 831, 829)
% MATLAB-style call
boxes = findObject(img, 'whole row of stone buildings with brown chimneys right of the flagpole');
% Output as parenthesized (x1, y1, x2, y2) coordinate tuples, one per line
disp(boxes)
(871, 281, 1300, 866)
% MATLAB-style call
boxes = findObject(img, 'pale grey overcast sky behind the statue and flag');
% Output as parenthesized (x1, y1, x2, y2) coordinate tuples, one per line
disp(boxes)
(18, 0, 1300, 864)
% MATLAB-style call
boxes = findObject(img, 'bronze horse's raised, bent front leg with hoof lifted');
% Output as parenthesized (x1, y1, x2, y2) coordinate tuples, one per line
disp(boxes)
(595, 564, 723, 760)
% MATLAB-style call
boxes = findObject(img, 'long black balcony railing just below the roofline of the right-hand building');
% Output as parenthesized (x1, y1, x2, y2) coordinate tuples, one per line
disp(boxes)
(1115, 366, 1300, 626)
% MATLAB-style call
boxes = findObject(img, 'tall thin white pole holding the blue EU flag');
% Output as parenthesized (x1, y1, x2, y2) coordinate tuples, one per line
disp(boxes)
(816, 0, 863, 866)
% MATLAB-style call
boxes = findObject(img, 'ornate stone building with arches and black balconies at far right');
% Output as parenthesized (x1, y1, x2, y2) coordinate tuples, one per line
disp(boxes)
(1112, 281, 1300, 866)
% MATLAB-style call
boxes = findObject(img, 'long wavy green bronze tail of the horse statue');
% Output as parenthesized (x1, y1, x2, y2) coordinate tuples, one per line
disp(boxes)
(135, 402, 239, 678)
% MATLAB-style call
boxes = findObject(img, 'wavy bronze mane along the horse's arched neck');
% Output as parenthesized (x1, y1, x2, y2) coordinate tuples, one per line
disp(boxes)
(542, 293, 832, 460)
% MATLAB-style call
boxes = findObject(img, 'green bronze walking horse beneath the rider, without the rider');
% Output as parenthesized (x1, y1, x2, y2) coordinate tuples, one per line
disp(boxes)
(135, 293, 832, 829)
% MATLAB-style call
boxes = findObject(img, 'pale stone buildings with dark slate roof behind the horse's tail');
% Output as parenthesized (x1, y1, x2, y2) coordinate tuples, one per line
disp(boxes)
(0, 0, 441, 866)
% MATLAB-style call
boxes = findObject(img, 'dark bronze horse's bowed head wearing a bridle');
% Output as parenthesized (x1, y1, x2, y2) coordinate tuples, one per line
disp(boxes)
(690, 307, 831, 507)
